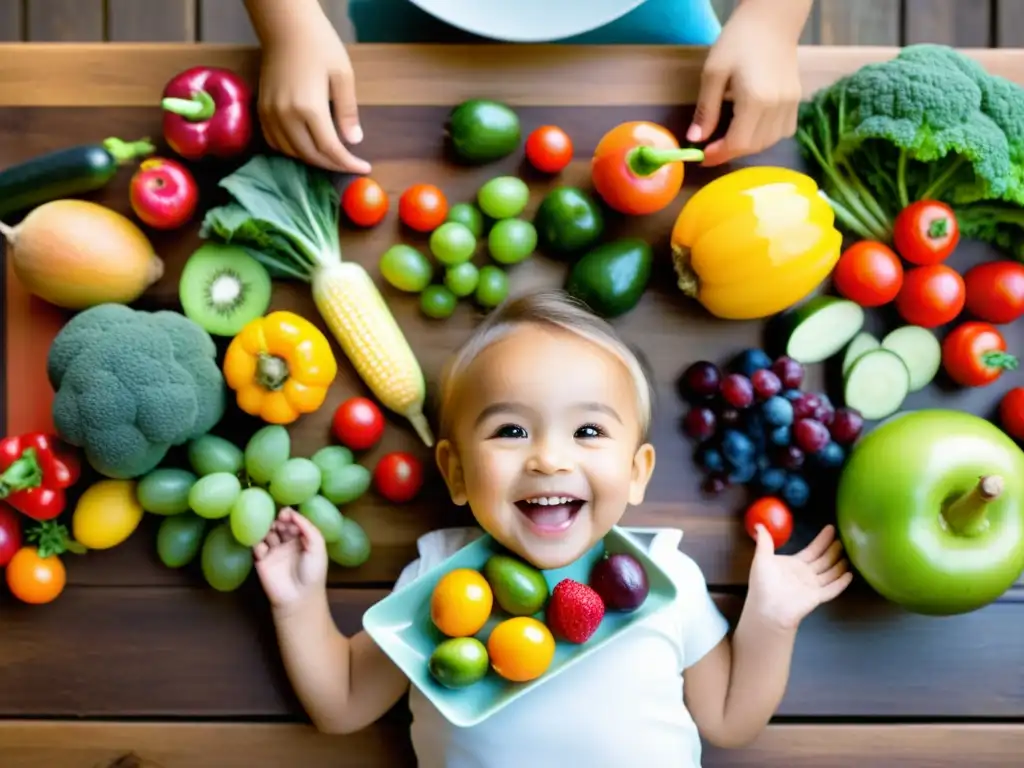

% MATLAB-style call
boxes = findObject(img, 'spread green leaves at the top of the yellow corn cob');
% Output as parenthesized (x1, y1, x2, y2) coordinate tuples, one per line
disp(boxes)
(200, 155, 341, 283)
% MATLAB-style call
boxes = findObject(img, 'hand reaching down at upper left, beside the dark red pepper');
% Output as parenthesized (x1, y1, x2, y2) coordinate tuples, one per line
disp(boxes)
(259, 18, 370, 173)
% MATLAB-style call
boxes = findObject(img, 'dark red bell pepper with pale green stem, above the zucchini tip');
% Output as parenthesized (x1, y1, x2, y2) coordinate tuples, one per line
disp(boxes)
(161, 67, 253, 161)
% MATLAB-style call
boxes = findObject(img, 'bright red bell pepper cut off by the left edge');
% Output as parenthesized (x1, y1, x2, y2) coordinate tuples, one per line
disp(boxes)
(0, 432, 81, 520)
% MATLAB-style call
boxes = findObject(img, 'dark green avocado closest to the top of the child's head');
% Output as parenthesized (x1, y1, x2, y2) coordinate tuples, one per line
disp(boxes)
(565, 238, 654, 317)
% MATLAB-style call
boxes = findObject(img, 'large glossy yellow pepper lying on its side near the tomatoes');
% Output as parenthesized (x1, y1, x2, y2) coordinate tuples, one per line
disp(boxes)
(672, 166, 843, 319)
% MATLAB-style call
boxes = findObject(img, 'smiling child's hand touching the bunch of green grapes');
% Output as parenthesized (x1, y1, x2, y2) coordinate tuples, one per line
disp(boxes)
(253, 507, 328, 608)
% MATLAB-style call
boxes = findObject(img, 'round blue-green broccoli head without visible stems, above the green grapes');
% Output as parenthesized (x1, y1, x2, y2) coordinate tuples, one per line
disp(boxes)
(47, 304, 227, 478)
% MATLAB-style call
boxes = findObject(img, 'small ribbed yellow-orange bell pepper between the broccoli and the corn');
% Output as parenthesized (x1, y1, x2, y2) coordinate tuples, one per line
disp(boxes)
(224, 311, 338, 424)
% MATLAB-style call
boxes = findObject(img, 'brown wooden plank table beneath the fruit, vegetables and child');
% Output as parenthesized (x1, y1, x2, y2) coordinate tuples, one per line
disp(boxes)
(0, 44, 1024, 768)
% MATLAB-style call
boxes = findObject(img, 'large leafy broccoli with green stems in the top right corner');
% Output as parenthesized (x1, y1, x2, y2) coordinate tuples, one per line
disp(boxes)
(797, 44, 1024, 255)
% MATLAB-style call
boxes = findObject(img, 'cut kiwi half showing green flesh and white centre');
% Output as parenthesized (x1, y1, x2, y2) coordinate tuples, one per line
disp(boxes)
(178, 243, 272, 336)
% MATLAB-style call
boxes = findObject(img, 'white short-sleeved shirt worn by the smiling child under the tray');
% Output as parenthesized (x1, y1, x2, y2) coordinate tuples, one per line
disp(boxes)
(395, 528, 729, 768)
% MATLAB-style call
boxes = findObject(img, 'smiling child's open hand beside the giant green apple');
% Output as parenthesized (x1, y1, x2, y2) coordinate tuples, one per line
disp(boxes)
(746, 524, 853, 630)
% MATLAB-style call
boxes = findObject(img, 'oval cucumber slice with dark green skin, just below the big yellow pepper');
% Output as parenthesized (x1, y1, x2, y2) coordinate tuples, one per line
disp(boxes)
(784, 296, 864, 365)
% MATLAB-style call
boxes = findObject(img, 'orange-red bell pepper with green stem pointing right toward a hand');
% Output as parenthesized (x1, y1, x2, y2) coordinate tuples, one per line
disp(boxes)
(591, 121, 703, 216)
